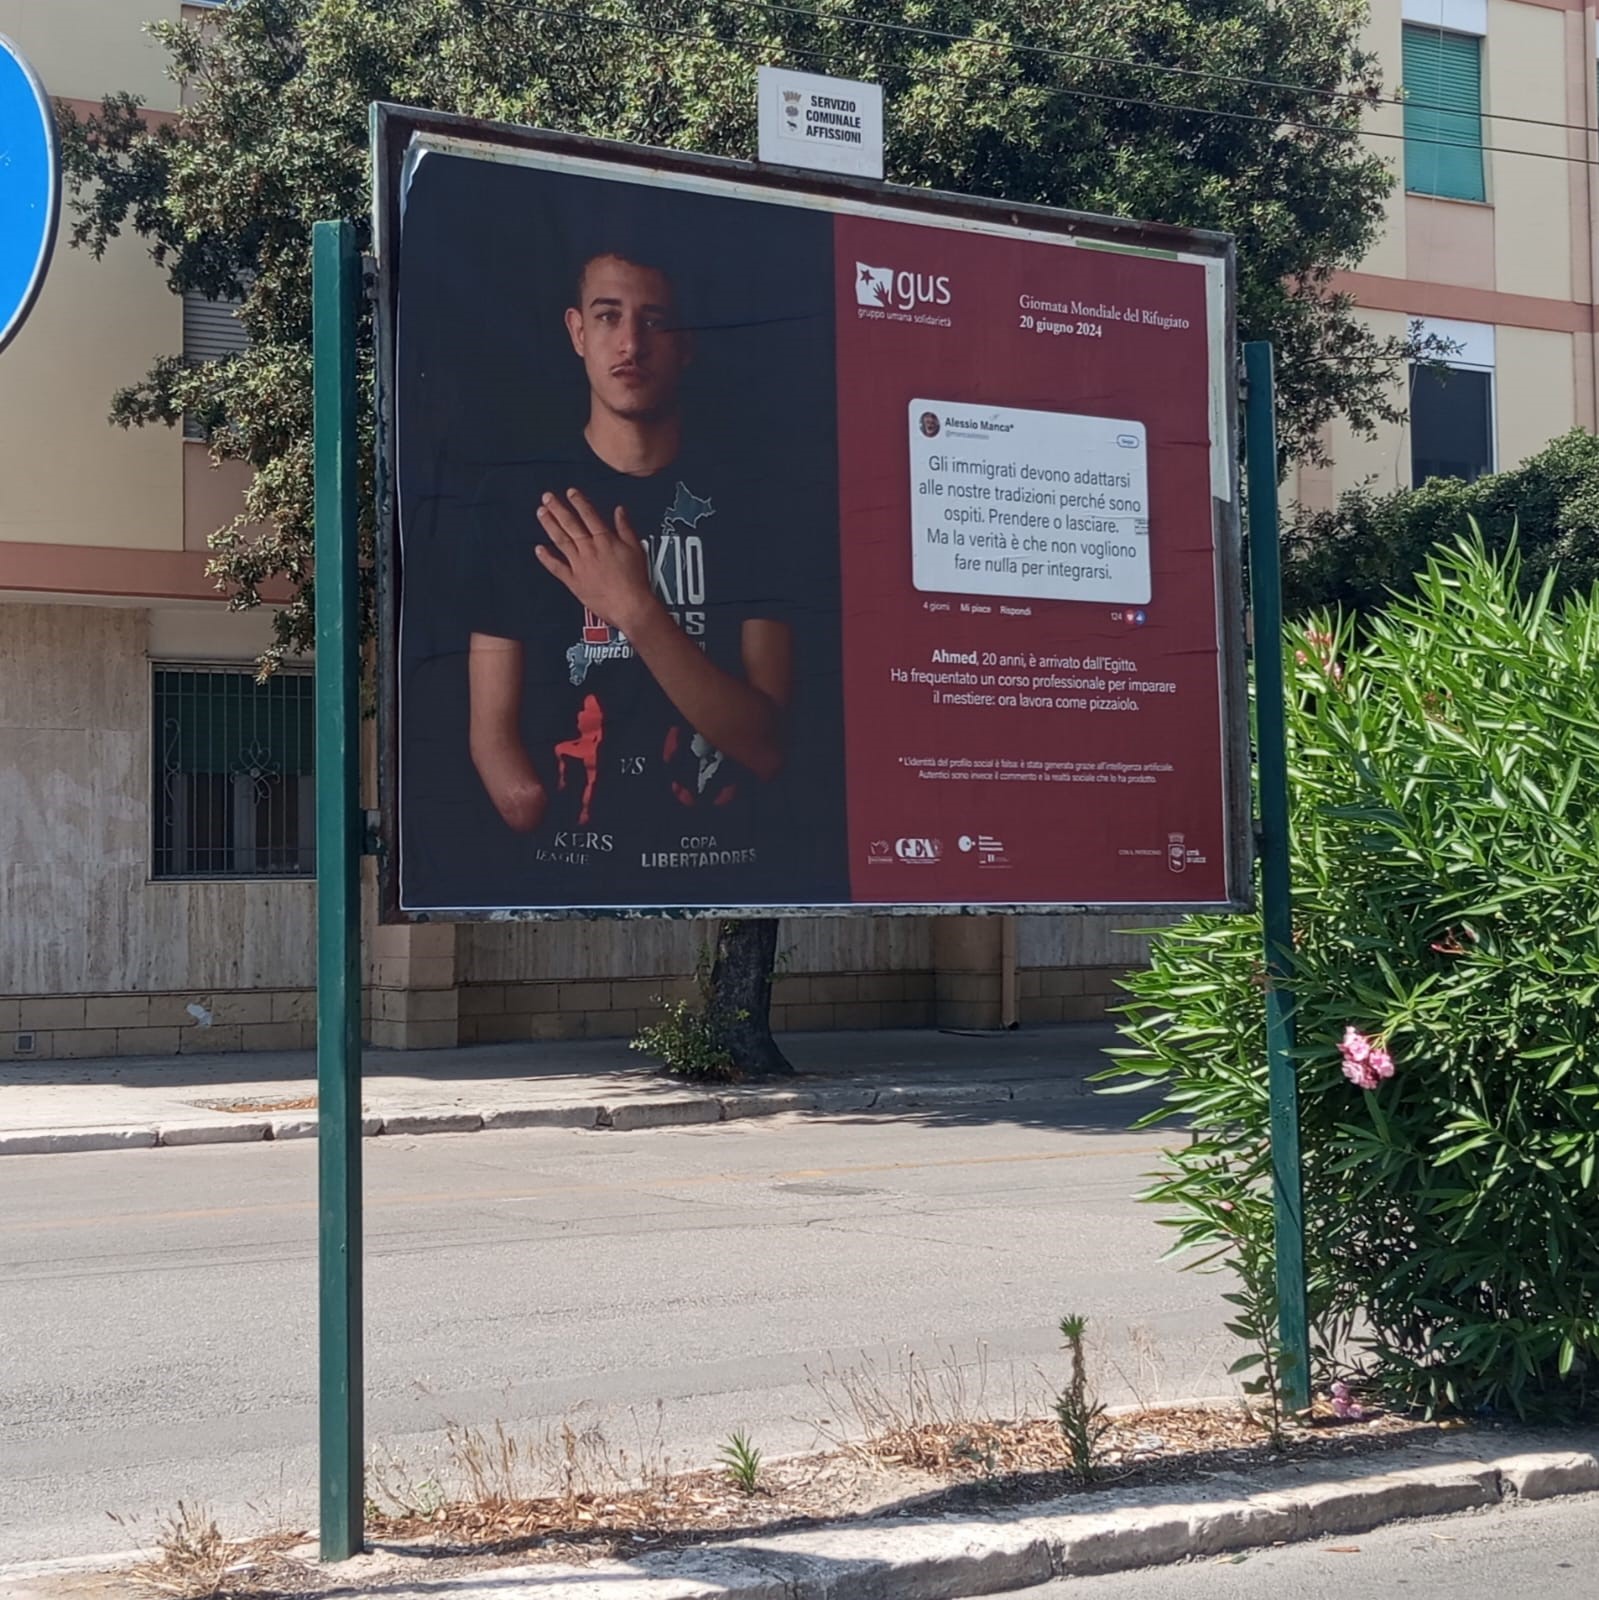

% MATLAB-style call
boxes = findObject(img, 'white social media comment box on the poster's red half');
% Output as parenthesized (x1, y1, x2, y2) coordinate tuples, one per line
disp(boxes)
(906, 400, 1149, 605)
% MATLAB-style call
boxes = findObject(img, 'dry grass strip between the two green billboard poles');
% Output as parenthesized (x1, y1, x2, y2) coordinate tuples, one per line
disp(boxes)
(368, 1395, 1437, 1560)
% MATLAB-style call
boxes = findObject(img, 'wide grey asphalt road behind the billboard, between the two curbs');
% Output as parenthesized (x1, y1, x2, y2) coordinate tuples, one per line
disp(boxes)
(0, 1099, 1232, 1563)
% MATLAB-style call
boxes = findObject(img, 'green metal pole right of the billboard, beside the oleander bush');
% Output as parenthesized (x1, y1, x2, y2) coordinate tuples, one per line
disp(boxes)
(1244, 344, 1311, 1411)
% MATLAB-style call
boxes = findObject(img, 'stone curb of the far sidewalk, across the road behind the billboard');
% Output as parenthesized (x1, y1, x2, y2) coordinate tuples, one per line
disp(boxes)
(0, 1078, 1090, 1155)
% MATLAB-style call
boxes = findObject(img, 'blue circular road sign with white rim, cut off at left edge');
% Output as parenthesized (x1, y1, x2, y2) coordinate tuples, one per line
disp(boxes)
(0, 34, 61, 361)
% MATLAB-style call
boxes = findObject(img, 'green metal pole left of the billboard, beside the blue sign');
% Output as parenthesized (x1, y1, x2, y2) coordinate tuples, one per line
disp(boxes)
(311, 222, 367, 1562)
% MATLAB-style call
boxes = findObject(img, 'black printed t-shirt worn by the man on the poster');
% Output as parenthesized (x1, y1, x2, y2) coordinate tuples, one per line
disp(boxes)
(461, 440, 794, 906)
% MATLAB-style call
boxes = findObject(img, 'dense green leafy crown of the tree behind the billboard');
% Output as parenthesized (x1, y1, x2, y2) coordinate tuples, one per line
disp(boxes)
(62, 0, 1412, 1059)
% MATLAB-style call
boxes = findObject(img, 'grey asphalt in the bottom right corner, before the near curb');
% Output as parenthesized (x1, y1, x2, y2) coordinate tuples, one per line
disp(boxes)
(1023, 1494, 1599, 1600)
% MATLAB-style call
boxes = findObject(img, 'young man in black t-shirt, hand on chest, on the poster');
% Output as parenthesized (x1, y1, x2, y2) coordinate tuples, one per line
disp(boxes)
(469, 250, 794, 904)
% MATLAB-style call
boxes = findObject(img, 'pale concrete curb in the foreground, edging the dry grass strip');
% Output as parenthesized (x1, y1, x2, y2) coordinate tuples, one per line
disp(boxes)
(360, 1451, 1599, 1600)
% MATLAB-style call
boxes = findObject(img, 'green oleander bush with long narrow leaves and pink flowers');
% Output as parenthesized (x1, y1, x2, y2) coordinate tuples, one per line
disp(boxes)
(1104, 528, 1599, 1416)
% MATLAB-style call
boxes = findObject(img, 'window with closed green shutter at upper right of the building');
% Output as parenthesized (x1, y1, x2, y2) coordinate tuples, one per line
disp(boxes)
(1404, 22, 1487, 200)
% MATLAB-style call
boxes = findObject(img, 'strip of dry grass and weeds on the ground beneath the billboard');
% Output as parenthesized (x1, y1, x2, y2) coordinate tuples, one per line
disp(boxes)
(109, 1320, 1437, 1600)
